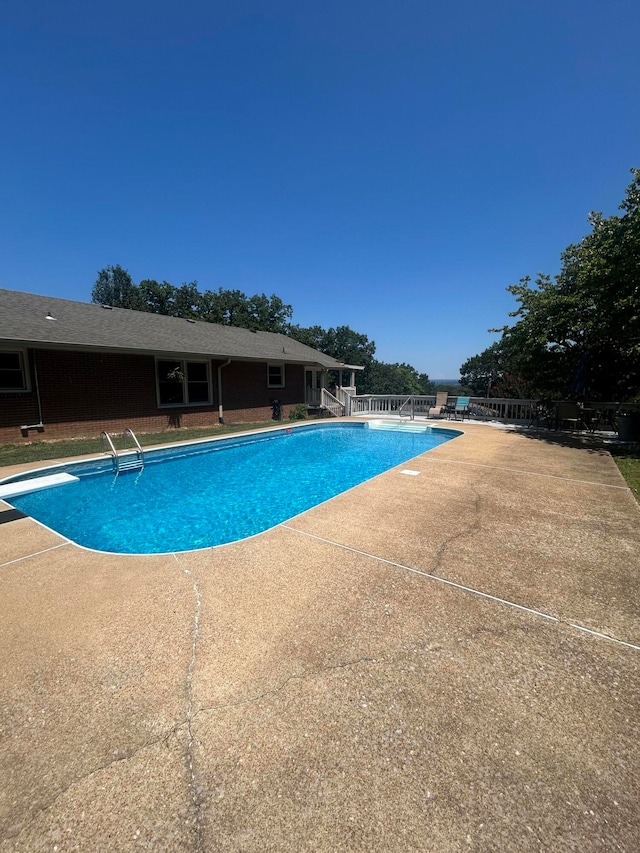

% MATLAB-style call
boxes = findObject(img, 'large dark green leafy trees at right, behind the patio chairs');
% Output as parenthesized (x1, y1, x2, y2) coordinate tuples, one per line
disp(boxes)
(460, 169, 640, 401)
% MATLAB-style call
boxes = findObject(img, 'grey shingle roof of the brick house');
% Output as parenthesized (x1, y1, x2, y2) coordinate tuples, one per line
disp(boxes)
(0, 289, 352, 368)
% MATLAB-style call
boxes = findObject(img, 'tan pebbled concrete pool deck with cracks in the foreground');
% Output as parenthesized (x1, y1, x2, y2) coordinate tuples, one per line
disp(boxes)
(0, 422, 640, 853)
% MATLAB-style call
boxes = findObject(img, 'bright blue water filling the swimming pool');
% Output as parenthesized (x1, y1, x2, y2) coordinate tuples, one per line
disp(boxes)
(3, 423, 459, 554)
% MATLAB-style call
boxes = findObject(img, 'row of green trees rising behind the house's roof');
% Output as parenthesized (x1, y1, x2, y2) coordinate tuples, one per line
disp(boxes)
(91, 265, 435, 394)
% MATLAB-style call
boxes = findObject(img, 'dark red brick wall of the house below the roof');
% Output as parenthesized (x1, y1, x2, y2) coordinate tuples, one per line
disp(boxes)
(0, 350, 304, 444)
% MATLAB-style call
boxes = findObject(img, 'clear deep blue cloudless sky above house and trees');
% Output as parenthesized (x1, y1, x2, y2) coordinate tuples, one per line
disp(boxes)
(0, 0, 640, 378)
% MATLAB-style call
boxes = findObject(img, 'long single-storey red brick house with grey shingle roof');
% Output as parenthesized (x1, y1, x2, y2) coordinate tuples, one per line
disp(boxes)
(0, 289, 357, 443)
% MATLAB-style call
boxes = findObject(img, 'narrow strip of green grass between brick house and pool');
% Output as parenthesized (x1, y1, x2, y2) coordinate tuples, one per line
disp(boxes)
(0, 421, 284, 467)
